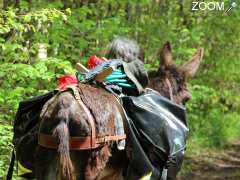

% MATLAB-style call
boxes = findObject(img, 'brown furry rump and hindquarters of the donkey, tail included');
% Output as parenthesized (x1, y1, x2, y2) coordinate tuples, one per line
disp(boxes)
(36, 84, 126, 180)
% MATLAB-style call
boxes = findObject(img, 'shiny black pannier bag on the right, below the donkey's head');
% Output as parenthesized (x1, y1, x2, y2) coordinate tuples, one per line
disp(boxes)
(122, 89, 188, 180)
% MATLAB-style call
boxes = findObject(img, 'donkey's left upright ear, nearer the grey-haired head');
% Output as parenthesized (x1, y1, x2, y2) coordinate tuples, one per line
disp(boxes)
(159, 42, 172, 66)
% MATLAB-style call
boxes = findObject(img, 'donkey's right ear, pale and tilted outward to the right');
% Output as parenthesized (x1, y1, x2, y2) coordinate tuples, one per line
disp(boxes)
(180, 48, 204, 79)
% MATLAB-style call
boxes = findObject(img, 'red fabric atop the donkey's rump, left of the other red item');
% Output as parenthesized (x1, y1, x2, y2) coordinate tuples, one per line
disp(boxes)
(58, 75, 78, 90)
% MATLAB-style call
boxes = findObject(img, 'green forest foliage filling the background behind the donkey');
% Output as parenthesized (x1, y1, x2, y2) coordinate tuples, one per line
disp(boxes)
(0, 0, 240, 177)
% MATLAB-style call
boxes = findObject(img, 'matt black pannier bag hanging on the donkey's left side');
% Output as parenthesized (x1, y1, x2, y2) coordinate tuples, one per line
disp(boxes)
(7, 91, 57, 180)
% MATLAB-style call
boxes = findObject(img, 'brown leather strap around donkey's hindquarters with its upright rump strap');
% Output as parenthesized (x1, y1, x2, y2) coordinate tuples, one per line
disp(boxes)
(38, 86, 126, 150)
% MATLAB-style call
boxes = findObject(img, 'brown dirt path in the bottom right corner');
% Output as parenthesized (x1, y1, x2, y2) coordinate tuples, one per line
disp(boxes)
(178, 141, 240, 180)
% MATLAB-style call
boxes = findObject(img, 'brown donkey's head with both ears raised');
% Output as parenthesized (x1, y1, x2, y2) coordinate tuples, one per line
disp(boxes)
(149, 42, 203, 105)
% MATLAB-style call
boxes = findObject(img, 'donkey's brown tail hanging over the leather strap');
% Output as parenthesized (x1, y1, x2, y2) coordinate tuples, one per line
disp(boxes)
(53, 121, 75, 180)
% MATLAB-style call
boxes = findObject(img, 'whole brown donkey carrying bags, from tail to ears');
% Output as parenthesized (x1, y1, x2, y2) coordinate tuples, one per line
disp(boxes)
(36, 42, 203, 180)
